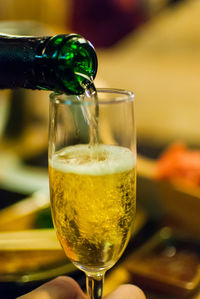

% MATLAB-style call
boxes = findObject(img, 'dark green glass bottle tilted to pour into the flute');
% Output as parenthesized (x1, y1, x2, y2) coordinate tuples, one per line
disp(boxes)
(0, 34, 97, 94)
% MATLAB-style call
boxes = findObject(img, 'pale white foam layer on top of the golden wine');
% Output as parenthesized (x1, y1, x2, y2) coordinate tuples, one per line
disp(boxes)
(50, 144, 136, 175)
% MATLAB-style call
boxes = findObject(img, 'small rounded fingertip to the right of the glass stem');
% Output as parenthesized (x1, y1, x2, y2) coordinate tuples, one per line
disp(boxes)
(105, 284, 146, 299)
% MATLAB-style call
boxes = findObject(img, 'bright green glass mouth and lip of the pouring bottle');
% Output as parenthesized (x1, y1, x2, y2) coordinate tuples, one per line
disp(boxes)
(54, 34, 98, 94)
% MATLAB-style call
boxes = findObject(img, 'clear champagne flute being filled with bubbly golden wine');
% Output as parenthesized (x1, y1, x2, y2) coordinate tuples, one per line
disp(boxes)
(49, 89, 136, 299)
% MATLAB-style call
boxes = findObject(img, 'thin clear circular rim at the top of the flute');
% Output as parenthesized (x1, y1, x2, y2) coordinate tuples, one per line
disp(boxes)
(49, 88, 135, 105)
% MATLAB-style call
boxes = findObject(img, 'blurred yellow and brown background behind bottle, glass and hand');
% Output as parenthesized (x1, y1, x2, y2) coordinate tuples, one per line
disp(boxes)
(0, 0, 200, 299)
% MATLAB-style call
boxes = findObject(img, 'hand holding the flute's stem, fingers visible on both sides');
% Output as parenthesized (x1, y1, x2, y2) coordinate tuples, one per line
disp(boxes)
(18, 276, 145, 299)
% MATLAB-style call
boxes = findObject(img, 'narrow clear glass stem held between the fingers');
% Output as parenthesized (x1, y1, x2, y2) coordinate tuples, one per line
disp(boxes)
(86, 273, 104, 299)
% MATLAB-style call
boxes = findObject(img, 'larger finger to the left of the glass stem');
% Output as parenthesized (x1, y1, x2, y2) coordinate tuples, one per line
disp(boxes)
(18, 276, 86, 299)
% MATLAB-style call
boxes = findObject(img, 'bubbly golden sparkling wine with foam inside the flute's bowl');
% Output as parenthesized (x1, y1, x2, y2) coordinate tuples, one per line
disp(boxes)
(49, 145, 136, 271)
